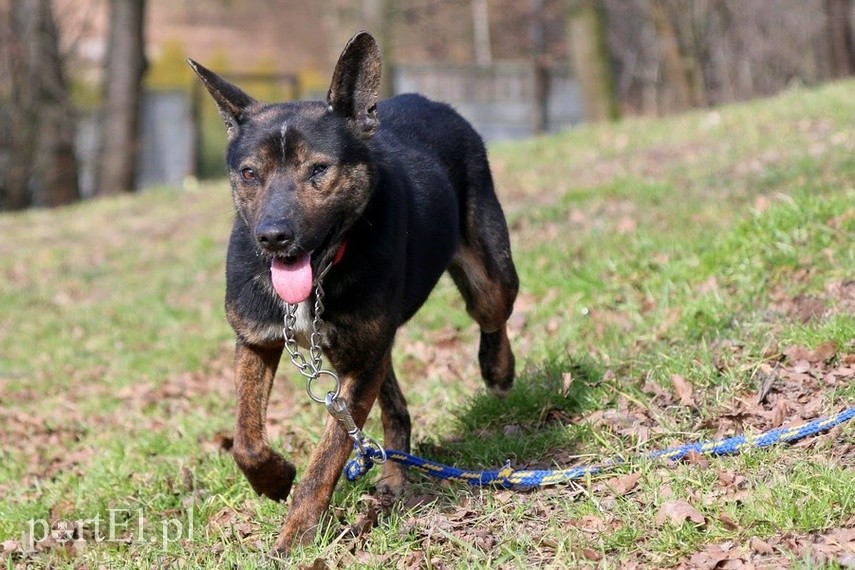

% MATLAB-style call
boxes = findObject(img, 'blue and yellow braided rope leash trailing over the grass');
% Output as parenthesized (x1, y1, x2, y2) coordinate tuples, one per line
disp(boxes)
(344, 407, 855, 489)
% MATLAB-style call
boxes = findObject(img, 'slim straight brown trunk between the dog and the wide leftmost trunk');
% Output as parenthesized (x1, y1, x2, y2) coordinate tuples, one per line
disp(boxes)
(95, 0, 146, 196)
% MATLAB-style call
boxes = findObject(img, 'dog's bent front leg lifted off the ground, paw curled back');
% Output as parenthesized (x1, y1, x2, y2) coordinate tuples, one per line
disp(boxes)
(232, 339, 296, 501)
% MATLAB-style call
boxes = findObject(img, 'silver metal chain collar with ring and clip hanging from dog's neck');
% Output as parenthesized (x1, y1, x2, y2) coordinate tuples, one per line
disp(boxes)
(282, 264, 386, 463)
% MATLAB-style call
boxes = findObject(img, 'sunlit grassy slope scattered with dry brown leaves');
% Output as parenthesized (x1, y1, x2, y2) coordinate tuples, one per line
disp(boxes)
(0, 83, 855, 568)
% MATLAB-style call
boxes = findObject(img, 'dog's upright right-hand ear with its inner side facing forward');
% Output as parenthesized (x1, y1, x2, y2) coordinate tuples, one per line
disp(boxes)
(327, 32, 382, 138)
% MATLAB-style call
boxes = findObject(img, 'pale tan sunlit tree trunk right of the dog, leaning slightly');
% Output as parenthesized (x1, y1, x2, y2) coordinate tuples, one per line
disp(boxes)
(567, 0, 620, 121)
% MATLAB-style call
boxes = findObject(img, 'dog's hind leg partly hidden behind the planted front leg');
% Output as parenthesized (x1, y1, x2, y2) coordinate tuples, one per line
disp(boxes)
(377, 351, 412, 496)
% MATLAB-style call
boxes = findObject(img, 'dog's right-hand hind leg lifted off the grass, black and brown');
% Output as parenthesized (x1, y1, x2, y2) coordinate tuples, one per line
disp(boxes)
(448, 156, 519, 396)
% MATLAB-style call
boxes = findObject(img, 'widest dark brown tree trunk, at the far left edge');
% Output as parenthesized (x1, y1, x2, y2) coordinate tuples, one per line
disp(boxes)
(0, 0, 80, 209)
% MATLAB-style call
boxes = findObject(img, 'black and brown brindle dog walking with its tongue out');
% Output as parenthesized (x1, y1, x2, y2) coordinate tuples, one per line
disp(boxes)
(189, 32, 519, 553)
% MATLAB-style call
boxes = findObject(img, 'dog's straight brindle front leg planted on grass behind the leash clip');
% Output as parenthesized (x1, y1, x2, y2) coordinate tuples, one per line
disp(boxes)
(273, 369, 383, 554)
